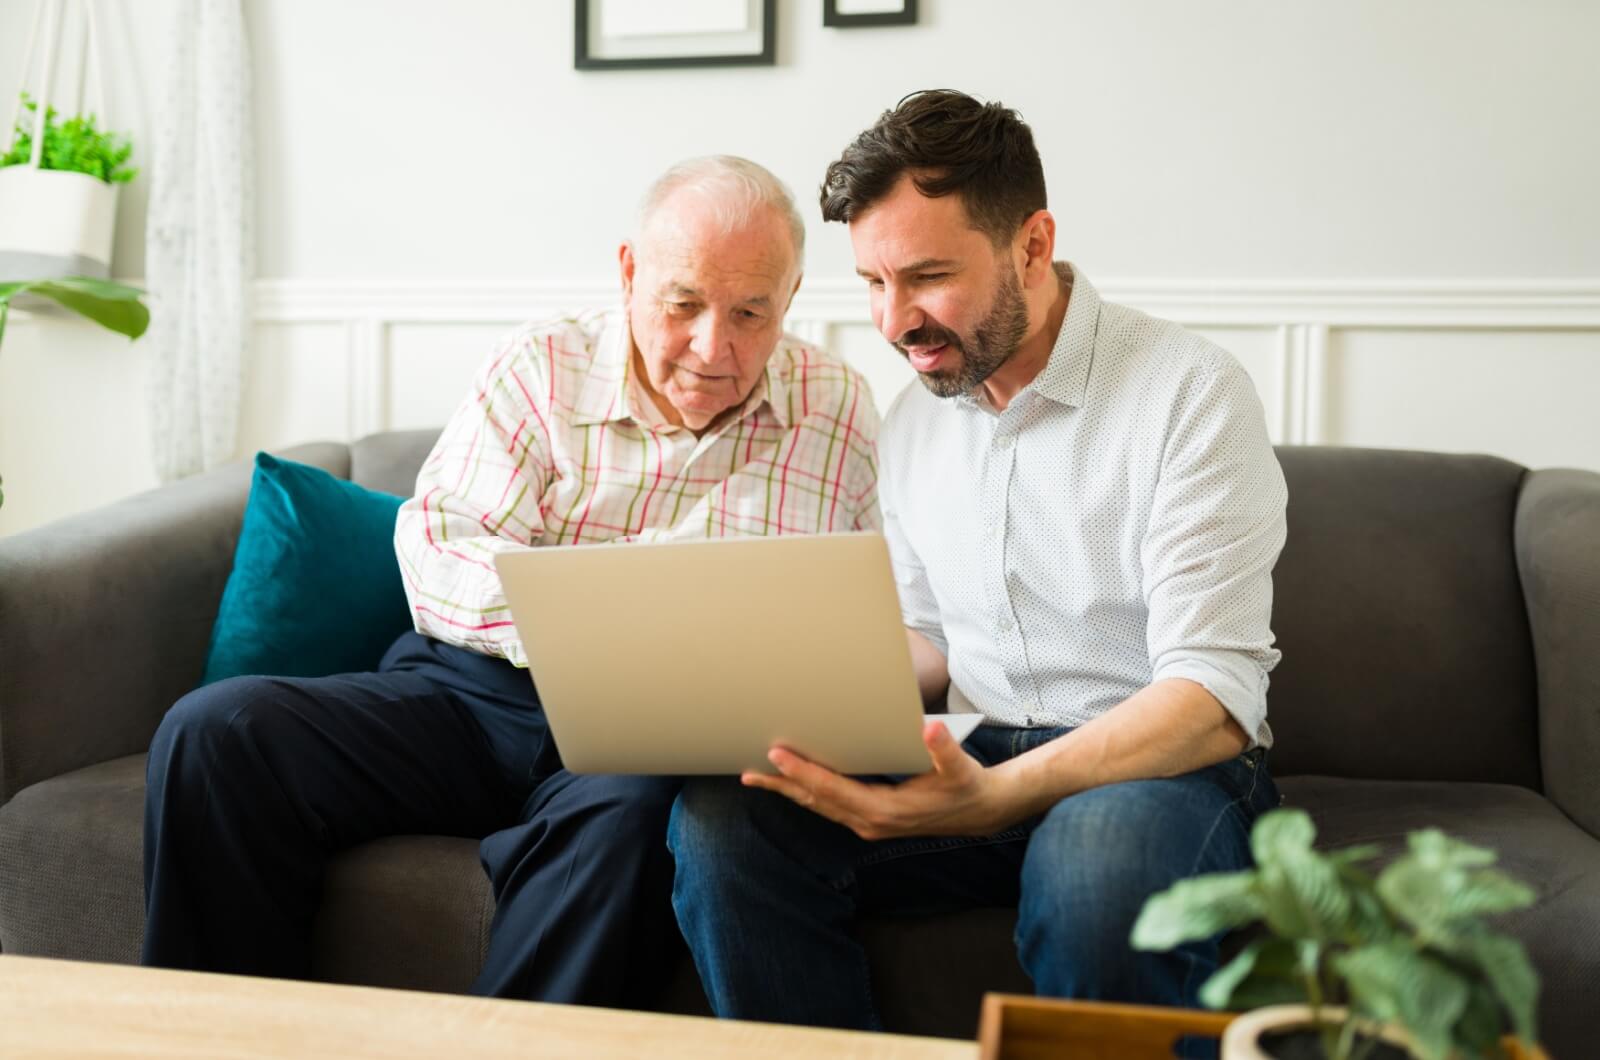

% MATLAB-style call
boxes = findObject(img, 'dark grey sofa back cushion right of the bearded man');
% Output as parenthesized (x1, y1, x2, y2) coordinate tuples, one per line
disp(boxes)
(1267, 447, 1539, 789)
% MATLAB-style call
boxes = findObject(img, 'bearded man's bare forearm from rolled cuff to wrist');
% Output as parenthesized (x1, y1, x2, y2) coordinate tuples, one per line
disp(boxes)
(995, 677, 1250, 826)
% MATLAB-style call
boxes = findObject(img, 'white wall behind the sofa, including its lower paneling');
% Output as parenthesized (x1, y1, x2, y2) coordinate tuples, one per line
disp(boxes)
(0, 0, 1600, 532)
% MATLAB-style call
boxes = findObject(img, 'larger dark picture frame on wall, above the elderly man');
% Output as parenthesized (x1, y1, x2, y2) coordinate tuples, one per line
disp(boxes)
(573, 0, 778, 70)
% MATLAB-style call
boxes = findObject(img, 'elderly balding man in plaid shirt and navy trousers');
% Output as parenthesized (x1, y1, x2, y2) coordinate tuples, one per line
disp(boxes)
(144, 157, 878, 1006)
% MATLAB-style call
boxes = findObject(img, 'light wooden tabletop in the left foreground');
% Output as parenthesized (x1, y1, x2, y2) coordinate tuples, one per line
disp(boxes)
(0, 954, 978, 1060)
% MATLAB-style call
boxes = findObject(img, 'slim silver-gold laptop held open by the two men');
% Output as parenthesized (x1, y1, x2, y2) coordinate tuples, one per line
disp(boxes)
(496, 533, 979, 775)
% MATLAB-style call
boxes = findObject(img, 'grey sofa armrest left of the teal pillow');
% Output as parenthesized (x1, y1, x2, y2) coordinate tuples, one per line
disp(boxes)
(0, 442, 349, 804)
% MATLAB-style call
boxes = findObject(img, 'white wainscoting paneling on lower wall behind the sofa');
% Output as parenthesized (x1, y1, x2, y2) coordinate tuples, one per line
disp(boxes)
(242, 279, 1600, 468)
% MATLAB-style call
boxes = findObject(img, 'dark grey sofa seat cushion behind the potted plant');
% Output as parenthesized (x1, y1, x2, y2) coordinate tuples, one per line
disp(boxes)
(1278, 777, 1600, 1057)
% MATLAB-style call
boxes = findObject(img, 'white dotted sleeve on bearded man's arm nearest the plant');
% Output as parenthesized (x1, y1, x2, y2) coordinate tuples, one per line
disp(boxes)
(1141, 359, 1288, 743)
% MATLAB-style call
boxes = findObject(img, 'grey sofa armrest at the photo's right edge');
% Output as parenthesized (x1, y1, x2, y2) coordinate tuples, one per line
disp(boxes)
(1517, 469, 1600, 837)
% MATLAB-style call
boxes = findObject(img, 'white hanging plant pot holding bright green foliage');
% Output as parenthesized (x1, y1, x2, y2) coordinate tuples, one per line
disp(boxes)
(0, 165, 117, 283)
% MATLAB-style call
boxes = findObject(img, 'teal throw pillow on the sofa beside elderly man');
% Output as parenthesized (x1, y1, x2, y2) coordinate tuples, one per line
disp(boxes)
(202, 453, 411, 684)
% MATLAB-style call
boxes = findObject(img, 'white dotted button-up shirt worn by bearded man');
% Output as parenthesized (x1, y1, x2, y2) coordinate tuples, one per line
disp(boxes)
(878, 264, 1288, 746)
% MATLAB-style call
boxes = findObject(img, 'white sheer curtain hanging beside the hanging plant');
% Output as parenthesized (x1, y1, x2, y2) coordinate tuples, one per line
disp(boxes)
(144, 0, 256, 482)
